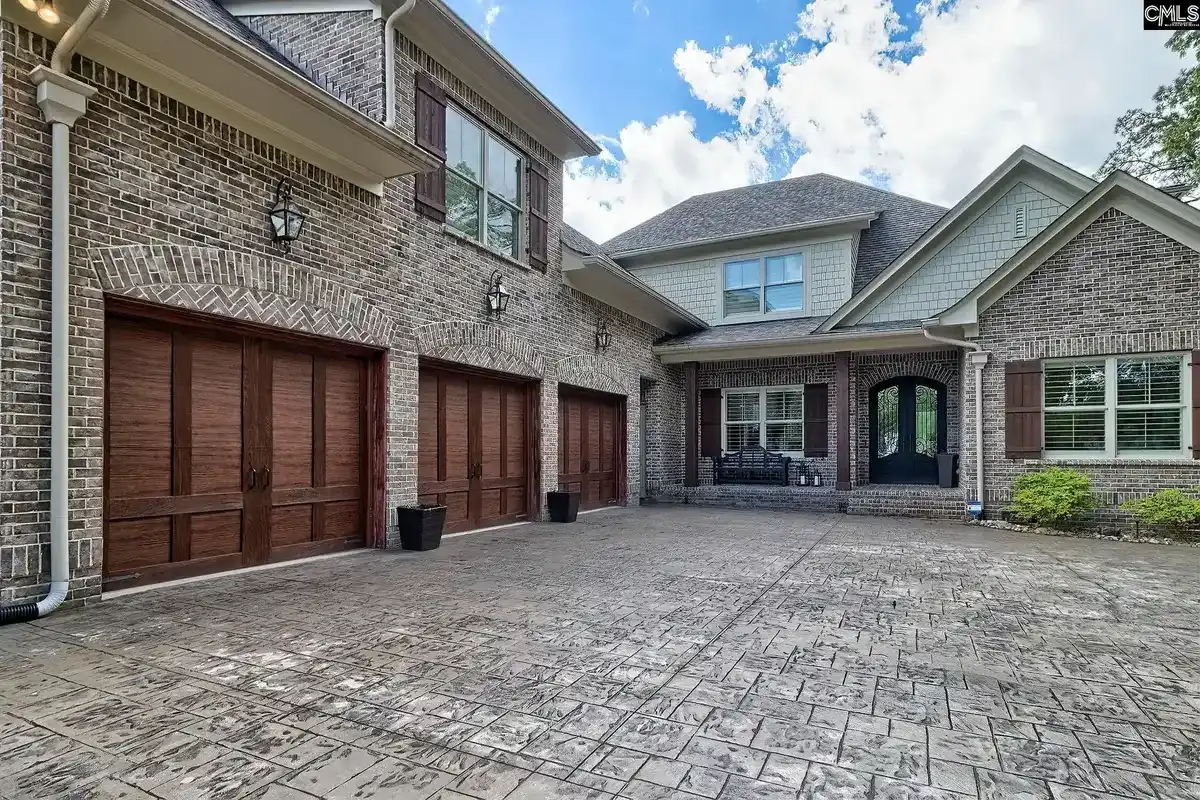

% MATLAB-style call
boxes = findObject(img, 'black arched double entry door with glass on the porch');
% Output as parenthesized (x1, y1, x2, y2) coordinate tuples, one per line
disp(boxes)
(870, 378, 946, 483)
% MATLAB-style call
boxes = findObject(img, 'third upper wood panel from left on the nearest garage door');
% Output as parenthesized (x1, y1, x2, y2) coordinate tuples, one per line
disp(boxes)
(271, 353, 312, 489)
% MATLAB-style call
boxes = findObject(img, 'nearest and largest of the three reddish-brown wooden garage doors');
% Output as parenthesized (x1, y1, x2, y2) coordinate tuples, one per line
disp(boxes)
(104, 315, 368, 588)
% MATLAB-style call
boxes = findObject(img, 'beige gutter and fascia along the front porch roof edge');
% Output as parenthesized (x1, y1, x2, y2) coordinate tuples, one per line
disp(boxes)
(652, 327, 934, 363)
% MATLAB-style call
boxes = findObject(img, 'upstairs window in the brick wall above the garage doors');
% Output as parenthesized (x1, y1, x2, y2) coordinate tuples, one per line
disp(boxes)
(446, 106, 524, 258)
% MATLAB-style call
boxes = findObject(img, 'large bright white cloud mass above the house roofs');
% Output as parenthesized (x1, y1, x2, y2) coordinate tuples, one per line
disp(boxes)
(565, 0, 1183, 240)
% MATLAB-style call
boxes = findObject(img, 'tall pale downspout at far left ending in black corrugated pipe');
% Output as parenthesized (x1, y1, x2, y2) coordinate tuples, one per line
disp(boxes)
(0, 0, 109, 624)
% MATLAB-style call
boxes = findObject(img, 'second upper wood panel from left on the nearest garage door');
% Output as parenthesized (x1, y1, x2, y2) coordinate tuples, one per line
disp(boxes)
(188, 337, 242, 494)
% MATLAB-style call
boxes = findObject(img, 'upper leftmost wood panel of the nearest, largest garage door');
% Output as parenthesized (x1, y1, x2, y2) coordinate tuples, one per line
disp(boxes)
(108, 320, 173, 498)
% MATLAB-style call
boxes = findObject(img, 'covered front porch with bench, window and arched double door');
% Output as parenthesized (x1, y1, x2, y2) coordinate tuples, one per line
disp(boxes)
(650, 325, 970, 518)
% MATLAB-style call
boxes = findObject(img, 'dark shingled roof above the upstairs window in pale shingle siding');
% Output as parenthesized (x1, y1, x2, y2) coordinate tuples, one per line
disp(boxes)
(605, 173, 944, 260)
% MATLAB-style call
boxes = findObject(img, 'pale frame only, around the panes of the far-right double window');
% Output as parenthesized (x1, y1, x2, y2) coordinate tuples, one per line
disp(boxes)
(1042, 353, 1192, 461)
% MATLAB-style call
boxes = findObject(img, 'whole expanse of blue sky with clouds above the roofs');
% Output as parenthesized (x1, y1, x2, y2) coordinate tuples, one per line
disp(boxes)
(448, 0, 1183, 241)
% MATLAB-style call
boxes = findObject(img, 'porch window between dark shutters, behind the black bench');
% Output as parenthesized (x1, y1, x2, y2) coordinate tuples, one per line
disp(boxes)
(721, 386, 804, 456)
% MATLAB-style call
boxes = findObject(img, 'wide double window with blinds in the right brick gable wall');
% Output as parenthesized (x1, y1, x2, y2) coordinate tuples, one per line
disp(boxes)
(1043, 354, 1190, 458)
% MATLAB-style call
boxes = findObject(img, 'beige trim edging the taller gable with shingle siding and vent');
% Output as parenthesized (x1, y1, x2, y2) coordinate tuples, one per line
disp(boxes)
(817, 145, 1096, 332)
